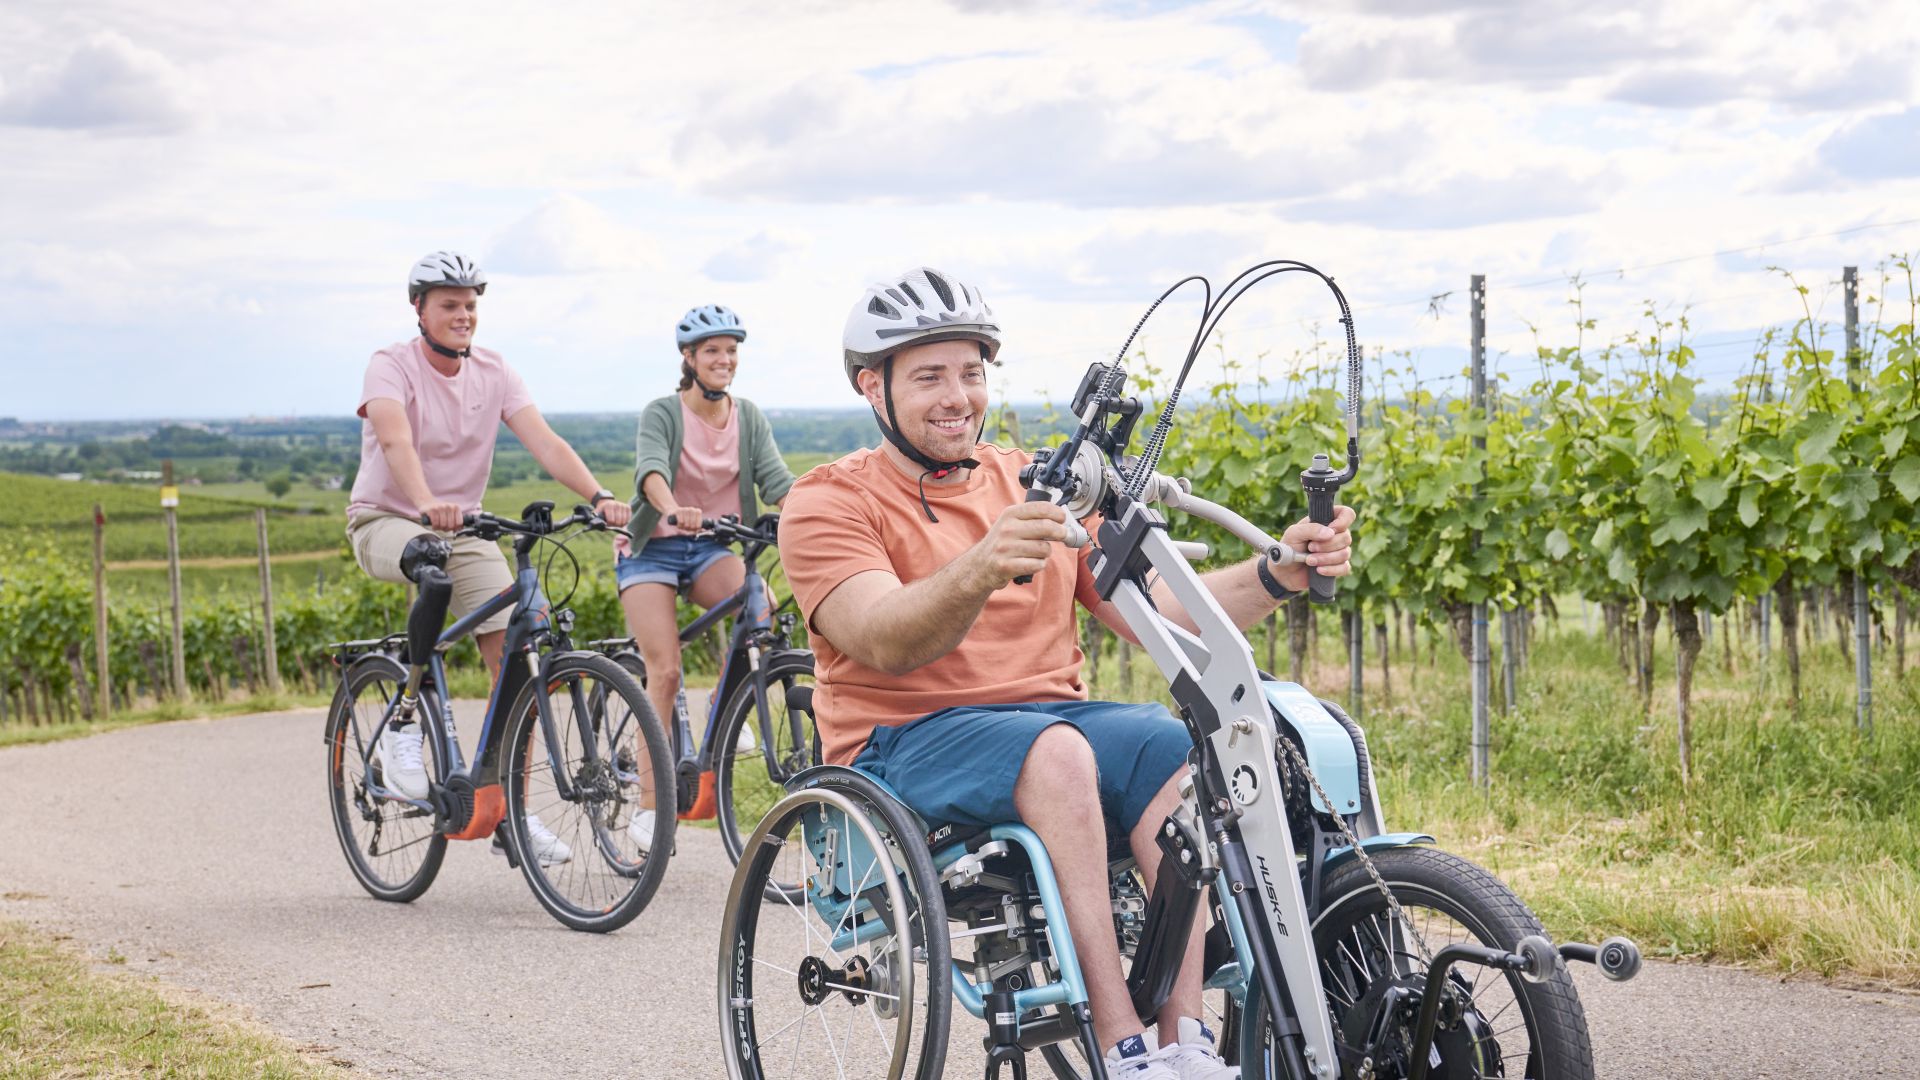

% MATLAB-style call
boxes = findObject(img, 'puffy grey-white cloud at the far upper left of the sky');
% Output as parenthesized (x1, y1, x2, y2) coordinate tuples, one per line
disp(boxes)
(0, 31, 192, 133)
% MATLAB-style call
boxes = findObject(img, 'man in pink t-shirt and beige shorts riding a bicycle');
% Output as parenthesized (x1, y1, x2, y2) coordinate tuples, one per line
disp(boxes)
(348, 252, 630, 845)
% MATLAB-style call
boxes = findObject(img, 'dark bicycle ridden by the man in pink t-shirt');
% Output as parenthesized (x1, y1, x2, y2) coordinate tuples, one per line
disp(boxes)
(326, 502, 674, 934)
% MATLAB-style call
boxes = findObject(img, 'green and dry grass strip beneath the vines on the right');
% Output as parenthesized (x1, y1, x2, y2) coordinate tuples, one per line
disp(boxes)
(1094, 603, 1920, 986)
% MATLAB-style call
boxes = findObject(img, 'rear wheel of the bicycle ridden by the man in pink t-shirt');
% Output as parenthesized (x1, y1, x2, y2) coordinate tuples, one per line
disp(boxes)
(326, 655, 447, 903)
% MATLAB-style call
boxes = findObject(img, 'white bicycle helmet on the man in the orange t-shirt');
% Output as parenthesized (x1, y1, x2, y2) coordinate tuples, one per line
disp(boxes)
(841, 267, 1000, 392)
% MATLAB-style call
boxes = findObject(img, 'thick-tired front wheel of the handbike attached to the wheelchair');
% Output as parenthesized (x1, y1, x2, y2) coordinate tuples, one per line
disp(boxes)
(1240, 847, 1594, 1080)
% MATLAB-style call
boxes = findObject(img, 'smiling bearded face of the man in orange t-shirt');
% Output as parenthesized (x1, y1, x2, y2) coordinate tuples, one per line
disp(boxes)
(858, 340, 987, 461)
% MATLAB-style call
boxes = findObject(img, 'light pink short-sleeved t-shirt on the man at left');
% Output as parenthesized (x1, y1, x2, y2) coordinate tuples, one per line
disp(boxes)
(348, 338, 534, 517)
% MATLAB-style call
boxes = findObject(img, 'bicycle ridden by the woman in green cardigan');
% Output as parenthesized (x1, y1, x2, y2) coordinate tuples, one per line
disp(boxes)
(586, 513, 820, 880)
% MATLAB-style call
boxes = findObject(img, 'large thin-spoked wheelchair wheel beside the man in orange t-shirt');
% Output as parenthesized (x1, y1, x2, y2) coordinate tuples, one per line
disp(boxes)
(718, 771, 952, 1080)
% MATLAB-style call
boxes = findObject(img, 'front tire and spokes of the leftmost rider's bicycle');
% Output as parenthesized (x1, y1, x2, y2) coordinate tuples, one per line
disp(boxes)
(501, 653, 676, 934)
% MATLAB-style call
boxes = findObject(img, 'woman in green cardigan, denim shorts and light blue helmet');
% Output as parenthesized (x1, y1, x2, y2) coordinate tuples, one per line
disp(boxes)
(614, 304, 793, 849)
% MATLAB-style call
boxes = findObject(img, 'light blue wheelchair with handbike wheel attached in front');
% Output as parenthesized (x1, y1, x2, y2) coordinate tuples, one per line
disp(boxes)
(718, 682, 1638, 1078)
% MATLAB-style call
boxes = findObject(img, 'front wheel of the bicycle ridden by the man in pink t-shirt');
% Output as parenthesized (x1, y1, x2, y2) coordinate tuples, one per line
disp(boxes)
(501, 653, 674, 934)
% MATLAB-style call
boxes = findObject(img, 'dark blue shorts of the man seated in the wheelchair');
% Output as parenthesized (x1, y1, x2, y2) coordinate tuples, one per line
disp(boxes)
(854, 701, 1192, 834)
